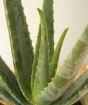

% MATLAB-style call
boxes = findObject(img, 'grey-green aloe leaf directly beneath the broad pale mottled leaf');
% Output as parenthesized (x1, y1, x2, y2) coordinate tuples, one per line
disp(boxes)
(52, 70, 88, 105)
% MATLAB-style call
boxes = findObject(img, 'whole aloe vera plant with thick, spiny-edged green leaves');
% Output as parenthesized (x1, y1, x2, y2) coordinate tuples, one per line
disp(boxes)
(0, 0, 88, 105)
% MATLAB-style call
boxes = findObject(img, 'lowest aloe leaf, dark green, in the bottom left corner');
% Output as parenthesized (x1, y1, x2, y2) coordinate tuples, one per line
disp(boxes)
(0, 87, 21, 105)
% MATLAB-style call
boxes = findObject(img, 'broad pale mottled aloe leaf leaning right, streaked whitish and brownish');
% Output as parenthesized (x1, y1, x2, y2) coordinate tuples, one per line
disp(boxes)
(35, 25, 88, 105)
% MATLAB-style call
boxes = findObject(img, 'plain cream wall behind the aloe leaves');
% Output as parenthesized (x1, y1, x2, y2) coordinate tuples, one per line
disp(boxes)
(0, 0, 88, 69)
